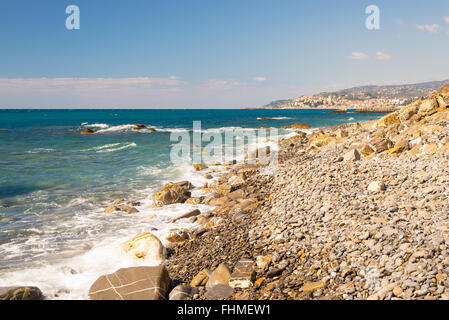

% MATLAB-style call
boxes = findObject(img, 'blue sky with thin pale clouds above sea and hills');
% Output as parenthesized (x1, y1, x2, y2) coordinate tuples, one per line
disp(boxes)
(0, 0, 449, 108)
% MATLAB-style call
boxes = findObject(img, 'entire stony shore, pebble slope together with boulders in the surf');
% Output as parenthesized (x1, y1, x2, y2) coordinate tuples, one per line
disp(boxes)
(0, 85, 449, 300)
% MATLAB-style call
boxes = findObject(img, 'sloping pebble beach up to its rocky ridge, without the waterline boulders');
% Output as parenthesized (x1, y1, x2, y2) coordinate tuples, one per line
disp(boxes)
(163, 89, 449, 300)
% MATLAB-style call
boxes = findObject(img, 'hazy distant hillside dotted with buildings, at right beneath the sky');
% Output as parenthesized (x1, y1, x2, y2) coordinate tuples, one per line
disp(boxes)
(320, 80, 449, 100)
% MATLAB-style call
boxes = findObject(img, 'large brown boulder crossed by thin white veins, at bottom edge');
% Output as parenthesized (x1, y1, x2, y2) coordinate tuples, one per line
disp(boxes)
(89, 266, 171, 300)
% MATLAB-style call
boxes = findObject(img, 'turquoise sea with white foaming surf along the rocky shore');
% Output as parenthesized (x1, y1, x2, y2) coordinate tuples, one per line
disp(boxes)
(0, 109, 382, 300)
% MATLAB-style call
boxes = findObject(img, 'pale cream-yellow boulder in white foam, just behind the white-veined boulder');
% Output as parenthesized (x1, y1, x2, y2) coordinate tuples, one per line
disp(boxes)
(121, 232, 167, 263)
